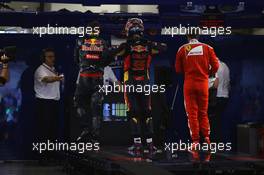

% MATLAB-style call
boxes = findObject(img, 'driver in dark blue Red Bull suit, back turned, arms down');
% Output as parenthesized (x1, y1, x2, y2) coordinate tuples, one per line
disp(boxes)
(74, 21, 114, 141)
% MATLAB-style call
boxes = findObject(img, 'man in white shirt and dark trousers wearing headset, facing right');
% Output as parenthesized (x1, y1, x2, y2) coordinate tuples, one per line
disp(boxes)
(34, 48, 64, 161)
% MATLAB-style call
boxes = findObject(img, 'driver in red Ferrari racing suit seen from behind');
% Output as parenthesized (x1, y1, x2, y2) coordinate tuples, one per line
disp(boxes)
(175, 35, 219, 159)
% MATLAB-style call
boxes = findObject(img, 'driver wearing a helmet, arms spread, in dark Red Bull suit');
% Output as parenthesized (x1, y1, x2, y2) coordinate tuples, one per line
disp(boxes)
(114, 18, 167, 156)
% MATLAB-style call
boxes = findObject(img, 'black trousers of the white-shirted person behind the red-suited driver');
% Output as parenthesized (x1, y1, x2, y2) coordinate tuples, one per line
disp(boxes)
(210, 97, 228, 142)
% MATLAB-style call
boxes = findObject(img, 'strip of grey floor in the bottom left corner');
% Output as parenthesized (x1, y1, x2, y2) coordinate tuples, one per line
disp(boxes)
(0, 163, 66, 175)
